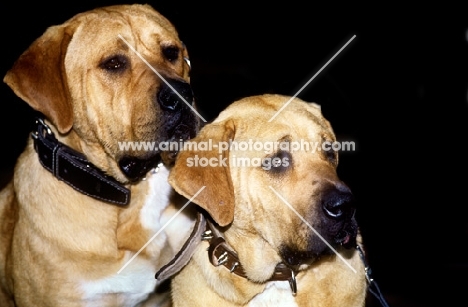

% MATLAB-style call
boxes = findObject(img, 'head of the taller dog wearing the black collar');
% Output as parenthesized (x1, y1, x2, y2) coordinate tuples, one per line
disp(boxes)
(4, 5, 198, 182)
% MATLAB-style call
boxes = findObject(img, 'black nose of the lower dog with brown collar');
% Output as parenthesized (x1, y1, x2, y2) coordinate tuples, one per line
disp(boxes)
(322, 184, 355, 220)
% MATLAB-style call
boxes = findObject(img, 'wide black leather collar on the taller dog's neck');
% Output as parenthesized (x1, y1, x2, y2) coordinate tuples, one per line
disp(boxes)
(31, 118, 130, 206)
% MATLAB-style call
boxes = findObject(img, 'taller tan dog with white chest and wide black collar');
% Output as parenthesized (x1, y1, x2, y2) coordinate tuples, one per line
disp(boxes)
(0, 5, 198, 307)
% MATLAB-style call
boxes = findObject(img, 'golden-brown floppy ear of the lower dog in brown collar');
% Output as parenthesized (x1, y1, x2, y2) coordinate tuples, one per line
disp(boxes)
(169, 120, 235, 226)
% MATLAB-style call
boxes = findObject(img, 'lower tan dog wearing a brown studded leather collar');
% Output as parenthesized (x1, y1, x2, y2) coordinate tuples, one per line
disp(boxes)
(169, 95, 367, 307)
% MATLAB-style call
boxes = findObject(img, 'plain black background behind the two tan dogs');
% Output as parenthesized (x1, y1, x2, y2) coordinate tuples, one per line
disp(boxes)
(0, 1, 468, 306)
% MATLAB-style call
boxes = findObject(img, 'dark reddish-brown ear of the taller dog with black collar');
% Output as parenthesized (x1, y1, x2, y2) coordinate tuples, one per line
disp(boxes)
(3, 26, 73, 133)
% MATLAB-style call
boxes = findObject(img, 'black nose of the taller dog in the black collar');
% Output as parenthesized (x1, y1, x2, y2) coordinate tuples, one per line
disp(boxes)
(157, 79, 193, 112)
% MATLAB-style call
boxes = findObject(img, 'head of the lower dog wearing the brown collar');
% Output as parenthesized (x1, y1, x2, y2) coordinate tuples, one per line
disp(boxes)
(169, 95, 358, 274)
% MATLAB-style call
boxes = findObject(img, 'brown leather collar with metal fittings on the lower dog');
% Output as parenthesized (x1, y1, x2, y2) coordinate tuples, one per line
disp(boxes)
(202, 219, 297, 296)
